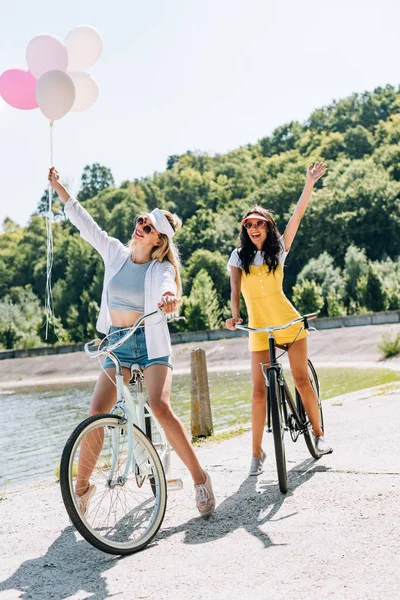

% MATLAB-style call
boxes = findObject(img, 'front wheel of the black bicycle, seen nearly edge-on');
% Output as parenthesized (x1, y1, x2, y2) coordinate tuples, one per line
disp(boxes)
(268, 369, 287, 494)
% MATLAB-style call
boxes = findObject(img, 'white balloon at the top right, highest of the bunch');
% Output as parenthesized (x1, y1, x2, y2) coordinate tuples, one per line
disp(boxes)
(64, 25, 103, 72)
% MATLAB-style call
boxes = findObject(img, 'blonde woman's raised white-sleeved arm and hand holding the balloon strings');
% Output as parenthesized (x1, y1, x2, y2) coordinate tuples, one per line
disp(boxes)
(47, 167, 123, 261)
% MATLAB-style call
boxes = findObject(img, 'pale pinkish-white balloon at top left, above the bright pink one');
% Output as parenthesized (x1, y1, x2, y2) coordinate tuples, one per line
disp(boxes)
(26, 34, 68, 79)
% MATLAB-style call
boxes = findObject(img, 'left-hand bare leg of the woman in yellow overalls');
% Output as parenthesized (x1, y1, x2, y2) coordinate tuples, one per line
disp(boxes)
(251, 350, 269, 458)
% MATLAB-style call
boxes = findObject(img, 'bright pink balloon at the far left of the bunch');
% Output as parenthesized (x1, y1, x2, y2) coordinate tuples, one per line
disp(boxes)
(0, 69, 38, 110)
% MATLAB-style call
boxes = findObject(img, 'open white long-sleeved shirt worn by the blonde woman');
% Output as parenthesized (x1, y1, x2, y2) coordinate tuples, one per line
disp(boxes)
(64, 198, 177, 359)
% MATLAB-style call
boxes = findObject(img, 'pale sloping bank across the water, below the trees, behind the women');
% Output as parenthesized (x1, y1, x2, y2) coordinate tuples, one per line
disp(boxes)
(0, 324, 400, 392)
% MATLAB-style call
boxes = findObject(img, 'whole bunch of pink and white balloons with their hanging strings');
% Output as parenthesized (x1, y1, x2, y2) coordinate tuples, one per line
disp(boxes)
(0, 25, 103, 339)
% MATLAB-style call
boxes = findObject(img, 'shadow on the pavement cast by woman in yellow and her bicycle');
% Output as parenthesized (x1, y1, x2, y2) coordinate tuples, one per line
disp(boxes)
(158, 458, 329, 548)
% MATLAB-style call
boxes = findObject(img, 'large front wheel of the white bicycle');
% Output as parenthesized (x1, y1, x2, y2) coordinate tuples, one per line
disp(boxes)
(60, 415, 167, 555)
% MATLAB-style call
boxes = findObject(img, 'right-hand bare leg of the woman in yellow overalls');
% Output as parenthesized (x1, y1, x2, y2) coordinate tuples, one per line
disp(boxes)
(288, 338, 323, 437)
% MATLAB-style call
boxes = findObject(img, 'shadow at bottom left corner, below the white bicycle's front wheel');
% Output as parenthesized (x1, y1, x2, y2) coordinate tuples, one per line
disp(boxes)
(0, 525, 119, 600)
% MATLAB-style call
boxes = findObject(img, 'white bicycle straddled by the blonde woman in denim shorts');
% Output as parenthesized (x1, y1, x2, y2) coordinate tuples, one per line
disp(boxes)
(60, 311, 182, 555)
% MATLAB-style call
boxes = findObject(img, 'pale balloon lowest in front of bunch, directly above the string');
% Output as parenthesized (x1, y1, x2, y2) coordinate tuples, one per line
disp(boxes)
(36, 71, 75, 121)
